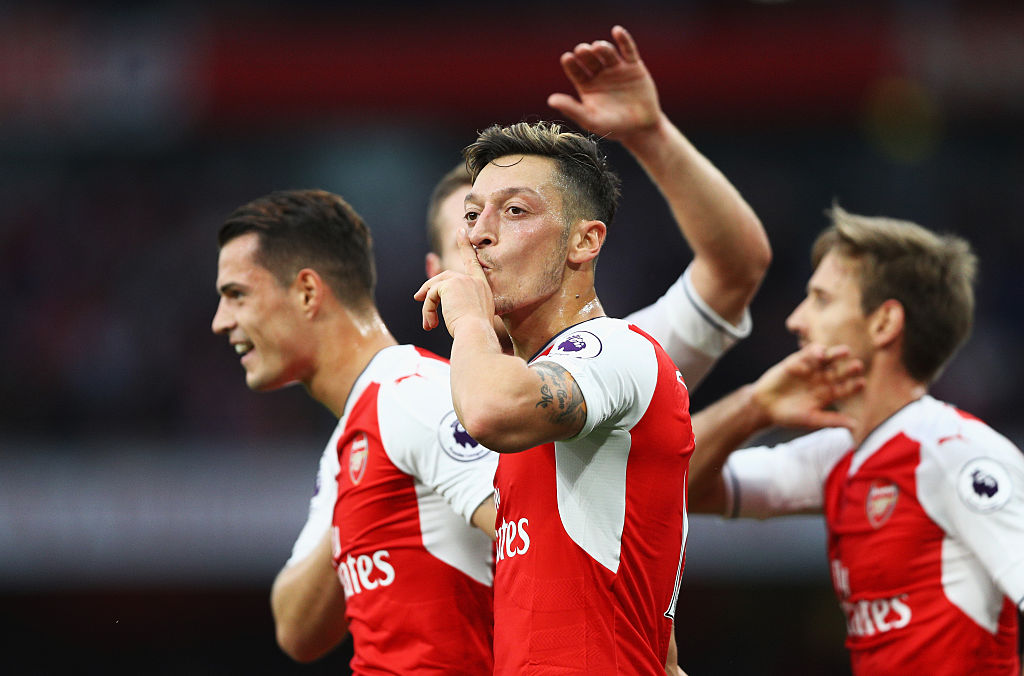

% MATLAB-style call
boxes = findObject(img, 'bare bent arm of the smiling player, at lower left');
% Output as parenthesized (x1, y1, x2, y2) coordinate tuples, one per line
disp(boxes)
(270, 531, 348, 662)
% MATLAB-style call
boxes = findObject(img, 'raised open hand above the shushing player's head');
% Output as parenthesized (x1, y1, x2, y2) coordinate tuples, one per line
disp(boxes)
(548, 26, 662, 140)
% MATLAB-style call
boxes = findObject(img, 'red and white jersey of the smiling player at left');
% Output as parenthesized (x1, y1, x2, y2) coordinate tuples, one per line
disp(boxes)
(309, 345, 497, 676)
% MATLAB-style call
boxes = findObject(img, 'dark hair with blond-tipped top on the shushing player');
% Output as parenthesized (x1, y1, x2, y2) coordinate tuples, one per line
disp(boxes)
(463, 122, 621, 225)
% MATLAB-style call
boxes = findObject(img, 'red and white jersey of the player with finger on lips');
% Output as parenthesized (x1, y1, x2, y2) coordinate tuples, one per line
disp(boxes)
(495, 318, 693, 676)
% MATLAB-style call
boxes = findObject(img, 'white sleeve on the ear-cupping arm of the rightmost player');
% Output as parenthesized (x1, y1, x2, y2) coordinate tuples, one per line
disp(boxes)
(722, 427, 853, 518)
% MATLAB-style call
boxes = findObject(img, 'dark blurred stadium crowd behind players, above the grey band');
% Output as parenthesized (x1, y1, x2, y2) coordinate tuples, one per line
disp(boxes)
(0, 2, 1024, 443)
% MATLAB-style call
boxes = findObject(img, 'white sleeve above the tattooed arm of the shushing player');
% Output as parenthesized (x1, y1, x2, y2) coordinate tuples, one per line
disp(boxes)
(532, 319, 658, 438)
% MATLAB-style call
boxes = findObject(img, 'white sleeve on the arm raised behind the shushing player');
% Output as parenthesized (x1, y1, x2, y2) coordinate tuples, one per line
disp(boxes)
(625, 266, 753, 390)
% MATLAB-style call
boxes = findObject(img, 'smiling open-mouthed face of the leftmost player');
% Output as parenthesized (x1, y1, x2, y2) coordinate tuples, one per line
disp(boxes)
(211, 233, 310, 390)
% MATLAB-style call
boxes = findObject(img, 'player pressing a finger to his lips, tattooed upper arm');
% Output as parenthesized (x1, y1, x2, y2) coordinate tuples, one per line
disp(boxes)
(415, 122, 693, 674)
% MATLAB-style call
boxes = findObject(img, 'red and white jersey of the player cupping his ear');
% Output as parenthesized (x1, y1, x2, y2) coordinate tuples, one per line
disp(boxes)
(725, 396, 1024, 676)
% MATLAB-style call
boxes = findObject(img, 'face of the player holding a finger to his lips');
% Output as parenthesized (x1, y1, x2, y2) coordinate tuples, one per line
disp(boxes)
(465, 155, 567, 315)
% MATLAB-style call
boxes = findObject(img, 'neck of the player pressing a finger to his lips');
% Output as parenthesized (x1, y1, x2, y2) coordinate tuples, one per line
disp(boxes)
(503, 286, 604, 361)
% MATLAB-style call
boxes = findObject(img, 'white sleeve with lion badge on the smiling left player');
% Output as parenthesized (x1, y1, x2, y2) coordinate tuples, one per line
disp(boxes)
(377, 372, 498, 523)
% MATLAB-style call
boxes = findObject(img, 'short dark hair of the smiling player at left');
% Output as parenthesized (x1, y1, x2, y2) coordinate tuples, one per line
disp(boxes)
(217, 189, 377, 308)
